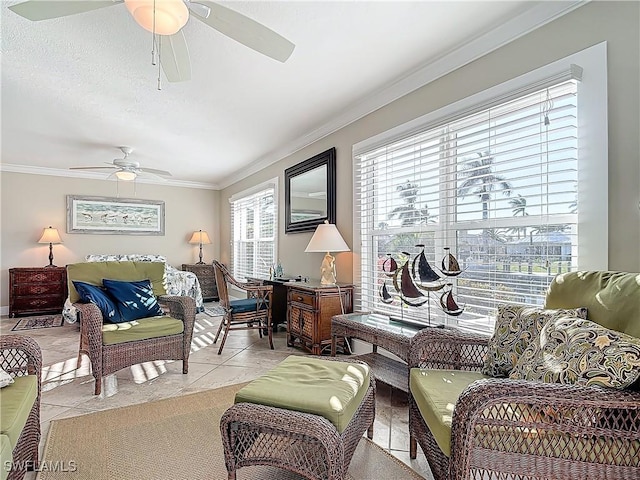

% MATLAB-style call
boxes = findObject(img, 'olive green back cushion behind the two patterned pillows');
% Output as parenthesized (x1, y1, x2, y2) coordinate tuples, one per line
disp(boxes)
(545, 272, 640, 338)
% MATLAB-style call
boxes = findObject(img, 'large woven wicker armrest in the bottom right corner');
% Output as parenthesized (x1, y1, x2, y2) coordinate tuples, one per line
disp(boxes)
(450, 378, 640, 479)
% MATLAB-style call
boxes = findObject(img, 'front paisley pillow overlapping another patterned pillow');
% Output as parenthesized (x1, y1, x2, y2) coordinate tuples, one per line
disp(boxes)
(509, 317, 640, 389)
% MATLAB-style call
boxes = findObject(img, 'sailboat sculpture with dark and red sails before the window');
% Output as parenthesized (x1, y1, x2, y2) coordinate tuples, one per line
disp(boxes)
(380, 244, 464, 321)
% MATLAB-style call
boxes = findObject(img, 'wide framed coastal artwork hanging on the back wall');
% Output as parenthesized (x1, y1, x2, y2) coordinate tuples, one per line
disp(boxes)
(67, 195, 164, 235)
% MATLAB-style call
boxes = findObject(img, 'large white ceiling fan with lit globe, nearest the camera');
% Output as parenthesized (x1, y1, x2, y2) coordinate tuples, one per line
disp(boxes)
(9, 0, 295, 82)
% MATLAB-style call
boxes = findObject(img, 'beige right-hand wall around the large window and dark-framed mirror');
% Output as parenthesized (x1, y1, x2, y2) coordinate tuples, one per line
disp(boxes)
(220, 2, 640, 282)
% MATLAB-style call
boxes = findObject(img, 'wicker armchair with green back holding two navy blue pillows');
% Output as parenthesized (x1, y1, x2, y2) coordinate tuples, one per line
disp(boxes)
(67, 262, 196, 395)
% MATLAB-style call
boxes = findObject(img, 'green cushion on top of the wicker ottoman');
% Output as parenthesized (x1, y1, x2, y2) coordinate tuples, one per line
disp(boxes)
(235, 355, 369, 432)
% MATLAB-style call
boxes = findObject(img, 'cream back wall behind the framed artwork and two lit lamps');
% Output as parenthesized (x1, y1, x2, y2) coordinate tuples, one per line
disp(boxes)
(0, 172, 220, 313)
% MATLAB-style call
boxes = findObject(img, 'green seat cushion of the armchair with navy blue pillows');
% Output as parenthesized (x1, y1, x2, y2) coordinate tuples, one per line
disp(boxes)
(102, 316, 184, 345)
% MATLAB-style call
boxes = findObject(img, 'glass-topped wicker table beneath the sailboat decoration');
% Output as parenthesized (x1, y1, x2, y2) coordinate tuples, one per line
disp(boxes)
(331, 312, 421, 392)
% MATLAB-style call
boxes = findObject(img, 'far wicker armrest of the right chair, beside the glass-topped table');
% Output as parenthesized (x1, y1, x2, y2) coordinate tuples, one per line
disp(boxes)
(408, 327, 489, 370)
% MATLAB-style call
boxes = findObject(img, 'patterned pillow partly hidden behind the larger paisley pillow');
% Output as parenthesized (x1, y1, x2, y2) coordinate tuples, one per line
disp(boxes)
(482, 305, 587, 377)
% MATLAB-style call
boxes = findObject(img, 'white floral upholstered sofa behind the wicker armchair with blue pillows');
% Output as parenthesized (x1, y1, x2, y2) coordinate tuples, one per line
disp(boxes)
(62, 254, 204, 323)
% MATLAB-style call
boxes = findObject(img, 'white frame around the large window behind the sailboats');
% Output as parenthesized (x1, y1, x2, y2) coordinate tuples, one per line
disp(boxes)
(353, 42, 608, 334)
